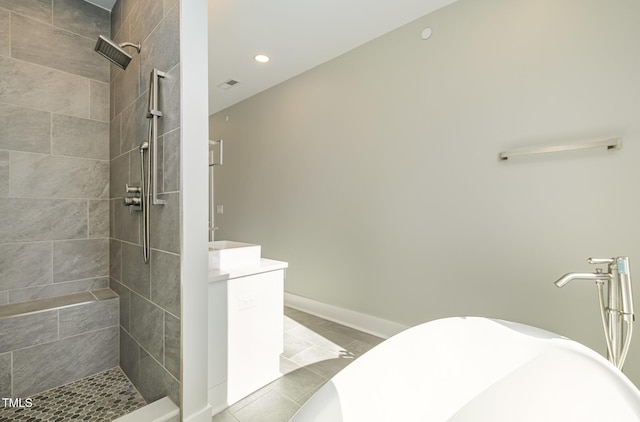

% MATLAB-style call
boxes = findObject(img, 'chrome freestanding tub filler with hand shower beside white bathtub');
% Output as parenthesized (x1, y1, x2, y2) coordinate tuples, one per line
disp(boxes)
(555, 256, 634, 370)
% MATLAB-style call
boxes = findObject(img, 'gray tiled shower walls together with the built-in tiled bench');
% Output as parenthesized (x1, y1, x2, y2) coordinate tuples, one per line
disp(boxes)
(0, 0, 181, 416)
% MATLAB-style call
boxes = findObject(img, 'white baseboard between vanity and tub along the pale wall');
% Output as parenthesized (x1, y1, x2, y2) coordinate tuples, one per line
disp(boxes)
(284, 292, 409, 339)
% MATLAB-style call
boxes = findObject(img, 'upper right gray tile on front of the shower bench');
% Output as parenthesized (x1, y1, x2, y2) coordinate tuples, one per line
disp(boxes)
(58, 298, 120, 339)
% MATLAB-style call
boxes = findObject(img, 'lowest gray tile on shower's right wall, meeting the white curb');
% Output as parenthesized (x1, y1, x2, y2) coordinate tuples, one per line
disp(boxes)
(138, 349, 180, 403)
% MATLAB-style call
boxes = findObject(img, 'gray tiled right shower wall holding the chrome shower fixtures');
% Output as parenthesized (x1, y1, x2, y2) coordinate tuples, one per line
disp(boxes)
(109, 0, 180, 404)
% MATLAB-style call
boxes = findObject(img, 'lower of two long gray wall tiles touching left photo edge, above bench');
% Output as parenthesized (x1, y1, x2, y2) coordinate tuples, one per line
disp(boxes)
(0, 198, 87, 243)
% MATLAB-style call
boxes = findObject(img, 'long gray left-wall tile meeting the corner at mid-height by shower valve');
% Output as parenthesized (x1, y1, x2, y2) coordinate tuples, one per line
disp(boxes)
(11, 152, 109, 199)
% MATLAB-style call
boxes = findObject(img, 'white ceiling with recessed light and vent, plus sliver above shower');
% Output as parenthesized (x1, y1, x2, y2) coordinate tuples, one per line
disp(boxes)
(87, 0, 456, 114)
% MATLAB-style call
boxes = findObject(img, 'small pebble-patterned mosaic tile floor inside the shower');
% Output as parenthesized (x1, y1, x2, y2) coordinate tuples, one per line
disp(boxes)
(0, 368, 146, 422)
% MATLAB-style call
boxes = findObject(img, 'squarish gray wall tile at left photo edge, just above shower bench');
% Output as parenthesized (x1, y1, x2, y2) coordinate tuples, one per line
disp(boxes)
(0, 242, 53, 290)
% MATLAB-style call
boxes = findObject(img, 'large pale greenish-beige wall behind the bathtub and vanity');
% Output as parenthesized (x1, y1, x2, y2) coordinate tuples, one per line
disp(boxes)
(210, 0, 640, 382)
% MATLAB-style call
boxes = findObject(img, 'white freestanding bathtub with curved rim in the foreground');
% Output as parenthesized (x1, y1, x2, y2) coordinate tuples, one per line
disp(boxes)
(291, 318, 640, 422)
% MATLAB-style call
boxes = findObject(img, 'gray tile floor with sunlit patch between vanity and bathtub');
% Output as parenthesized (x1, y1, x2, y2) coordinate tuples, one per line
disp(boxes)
(212, 307, 382, 422)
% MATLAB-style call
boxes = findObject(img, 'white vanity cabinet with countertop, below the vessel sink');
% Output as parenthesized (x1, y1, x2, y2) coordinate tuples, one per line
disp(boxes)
(208, 259, 288, 414)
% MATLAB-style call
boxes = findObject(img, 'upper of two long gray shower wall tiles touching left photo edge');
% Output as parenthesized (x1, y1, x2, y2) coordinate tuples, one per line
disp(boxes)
(0, 57, 89, 117)
